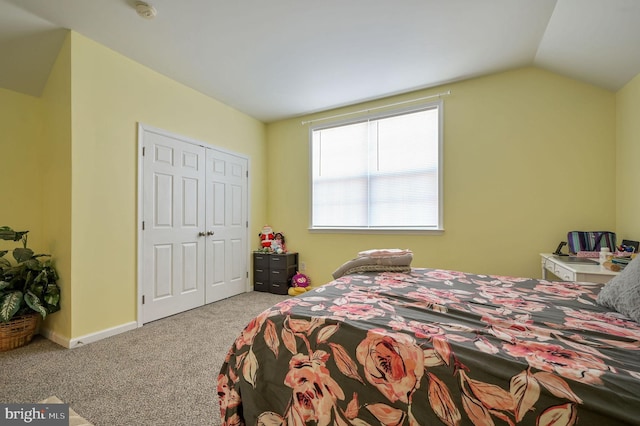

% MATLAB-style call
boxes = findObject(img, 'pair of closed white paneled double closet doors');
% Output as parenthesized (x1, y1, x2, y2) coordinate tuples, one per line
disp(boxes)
(138, 125, 249, 325)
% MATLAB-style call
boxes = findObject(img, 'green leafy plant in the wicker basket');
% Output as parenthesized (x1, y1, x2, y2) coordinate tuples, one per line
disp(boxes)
(0, 226, 60, 322)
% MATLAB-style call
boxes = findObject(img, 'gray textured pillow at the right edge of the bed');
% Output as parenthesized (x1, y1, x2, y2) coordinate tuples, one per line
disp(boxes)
(597, 256, 640, 322)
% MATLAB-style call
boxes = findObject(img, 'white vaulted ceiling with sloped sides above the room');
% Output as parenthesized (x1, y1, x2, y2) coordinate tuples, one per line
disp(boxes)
(0, 0, 640, 122)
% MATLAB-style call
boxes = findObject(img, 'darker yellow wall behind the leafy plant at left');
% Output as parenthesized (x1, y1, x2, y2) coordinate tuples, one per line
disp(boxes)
(0, 39, 72, 338)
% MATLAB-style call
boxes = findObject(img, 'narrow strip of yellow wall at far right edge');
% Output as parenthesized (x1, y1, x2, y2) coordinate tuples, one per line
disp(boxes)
(615, 74, 640, 241)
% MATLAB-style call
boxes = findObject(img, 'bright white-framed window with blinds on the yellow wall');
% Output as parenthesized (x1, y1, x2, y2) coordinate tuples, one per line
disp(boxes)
(311, 101, 442, 230)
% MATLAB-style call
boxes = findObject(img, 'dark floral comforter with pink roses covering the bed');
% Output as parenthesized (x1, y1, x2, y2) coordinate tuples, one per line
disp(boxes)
(217, 268, 640, 426)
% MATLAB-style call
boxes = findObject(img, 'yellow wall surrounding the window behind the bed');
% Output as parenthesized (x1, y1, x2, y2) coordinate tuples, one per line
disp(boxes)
(267, 68, 615, 284)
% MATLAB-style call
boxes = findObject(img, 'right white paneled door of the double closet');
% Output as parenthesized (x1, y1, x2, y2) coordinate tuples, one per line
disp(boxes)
(205, 149, 248, 303)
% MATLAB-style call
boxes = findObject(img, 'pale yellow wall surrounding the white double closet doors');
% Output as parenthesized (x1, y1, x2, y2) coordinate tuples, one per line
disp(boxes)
(71, 32, 266, 337)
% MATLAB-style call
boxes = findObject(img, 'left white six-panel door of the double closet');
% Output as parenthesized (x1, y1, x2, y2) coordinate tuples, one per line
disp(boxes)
(142, 131, 206, 322)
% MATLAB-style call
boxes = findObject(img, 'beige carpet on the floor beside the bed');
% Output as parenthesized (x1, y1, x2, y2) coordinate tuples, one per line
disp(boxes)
(0, 292, 289, 426)
